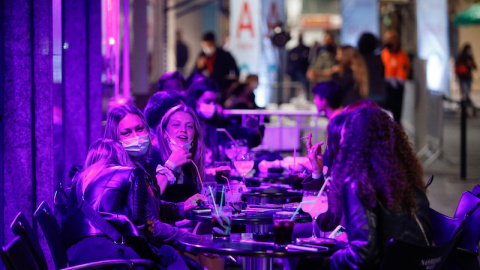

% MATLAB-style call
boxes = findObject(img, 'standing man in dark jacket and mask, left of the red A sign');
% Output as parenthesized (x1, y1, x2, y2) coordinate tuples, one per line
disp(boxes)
(194, 32, 239, 90)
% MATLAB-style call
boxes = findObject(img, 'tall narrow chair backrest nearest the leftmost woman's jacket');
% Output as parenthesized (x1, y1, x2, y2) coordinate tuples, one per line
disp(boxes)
(33, 201, 68, 269)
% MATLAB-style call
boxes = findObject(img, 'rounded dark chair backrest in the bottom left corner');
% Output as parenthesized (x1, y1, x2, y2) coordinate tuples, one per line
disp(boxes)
(0, 236, 41, 270)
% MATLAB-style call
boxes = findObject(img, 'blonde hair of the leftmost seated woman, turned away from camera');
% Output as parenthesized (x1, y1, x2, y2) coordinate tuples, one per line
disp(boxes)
(77, 139, 133, 196)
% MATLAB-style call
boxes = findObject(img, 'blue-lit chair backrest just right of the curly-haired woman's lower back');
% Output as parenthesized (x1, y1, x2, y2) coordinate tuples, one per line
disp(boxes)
(429, 208, 465, 245)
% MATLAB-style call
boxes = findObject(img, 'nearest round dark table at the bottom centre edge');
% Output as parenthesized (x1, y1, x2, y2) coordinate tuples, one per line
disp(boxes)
(176, 233, 338, 269)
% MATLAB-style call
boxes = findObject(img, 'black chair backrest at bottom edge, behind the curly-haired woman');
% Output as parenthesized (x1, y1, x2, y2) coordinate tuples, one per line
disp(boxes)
(380, 231, 463, 270)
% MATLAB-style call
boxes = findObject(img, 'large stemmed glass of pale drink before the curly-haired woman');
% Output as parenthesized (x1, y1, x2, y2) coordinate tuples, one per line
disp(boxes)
(302, 190, 328, 239)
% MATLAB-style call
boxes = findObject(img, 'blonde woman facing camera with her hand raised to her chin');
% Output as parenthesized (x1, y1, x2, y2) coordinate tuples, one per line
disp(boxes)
(157, 105, 205, 202)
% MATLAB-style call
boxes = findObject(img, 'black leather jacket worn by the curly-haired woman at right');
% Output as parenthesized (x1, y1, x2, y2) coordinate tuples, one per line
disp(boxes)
(330, 181, 432, 269)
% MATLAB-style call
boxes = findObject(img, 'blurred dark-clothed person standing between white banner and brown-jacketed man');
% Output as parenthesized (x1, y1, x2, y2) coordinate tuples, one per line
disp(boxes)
(287, 34, 310, 99)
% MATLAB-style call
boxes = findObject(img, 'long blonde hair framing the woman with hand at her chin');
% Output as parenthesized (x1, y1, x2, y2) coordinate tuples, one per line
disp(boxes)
(157, 104, 205, 186)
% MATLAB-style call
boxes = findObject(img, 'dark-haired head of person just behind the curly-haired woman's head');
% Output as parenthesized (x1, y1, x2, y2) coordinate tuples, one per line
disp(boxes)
(312, 81, 342, 119)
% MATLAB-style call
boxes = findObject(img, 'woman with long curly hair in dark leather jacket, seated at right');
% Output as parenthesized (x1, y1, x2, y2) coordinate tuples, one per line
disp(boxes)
(329, 108, 431, 269)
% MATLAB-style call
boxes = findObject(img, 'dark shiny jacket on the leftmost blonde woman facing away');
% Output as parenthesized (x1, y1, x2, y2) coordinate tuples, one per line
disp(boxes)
(62, 166, 149, 247)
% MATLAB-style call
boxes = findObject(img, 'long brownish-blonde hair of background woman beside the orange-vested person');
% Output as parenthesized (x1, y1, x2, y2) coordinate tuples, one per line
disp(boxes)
(340, 46, 369, 99)
